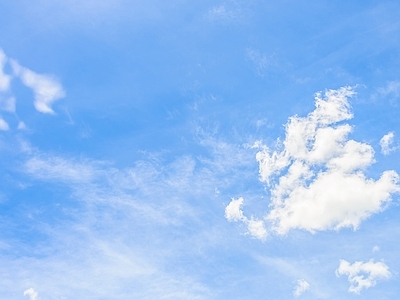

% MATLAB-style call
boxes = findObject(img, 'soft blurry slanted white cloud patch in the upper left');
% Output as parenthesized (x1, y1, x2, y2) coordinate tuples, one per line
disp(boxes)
(11, 60, 65, 114)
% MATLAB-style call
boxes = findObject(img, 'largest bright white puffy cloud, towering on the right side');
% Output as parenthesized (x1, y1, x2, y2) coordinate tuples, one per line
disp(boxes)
(227, 87, 400, 234)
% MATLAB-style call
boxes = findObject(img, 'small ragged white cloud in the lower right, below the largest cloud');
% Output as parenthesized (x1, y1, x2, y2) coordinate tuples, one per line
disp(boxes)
(336, 260, 391, 294)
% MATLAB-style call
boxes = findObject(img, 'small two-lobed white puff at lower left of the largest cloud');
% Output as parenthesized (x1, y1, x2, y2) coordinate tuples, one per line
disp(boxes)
(225, 197, 267, 240)
